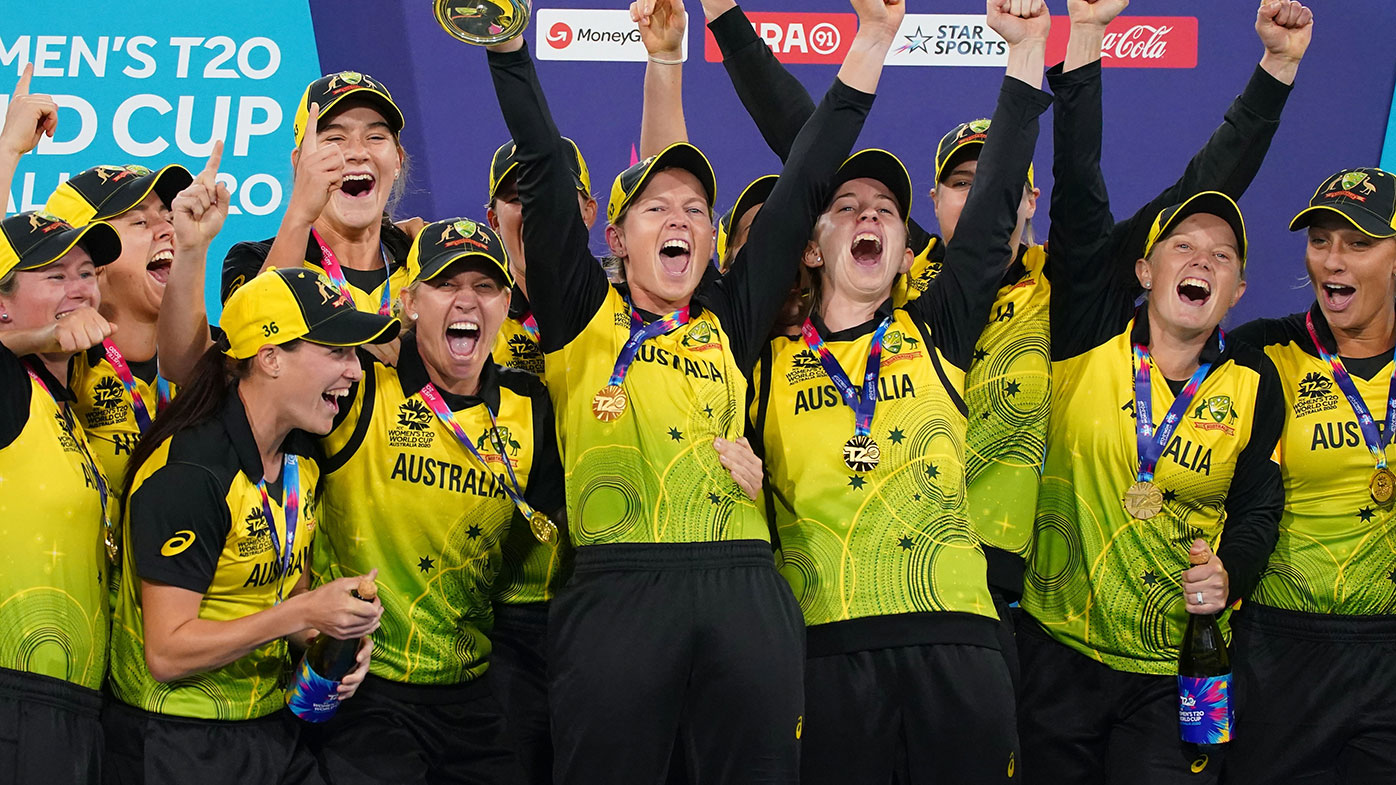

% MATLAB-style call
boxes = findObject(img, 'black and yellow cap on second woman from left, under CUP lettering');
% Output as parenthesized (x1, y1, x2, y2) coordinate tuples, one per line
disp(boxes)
(43, 163, 194, 226)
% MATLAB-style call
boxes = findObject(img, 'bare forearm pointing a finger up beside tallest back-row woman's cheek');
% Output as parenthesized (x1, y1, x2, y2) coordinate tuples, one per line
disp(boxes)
(258, 103, 345, 272)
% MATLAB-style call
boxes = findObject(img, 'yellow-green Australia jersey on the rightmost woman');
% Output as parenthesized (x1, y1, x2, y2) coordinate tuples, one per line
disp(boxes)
(1237, 305, 1396, 616)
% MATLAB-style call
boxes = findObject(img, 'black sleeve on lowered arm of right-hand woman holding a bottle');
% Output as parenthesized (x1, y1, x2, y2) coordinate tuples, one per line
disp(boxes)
(1217, 349, 1284, 603)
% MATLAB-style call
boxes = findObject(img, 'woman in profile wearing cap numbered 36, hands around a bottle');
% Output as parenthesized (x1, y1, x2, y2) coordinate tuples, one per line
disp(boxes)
(105, 268, 398, 785)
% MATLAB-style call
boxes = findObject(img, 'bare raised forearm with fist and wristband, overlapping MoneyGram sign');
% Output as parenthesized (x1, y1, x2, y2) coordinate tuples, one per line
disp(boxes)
(630, 0, 688, 158)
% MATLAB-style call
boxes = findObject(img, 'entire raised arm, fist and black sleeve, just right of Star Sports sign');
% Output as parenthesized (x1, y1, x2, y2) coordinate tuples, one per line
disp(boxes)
(907, 0, 1051, 369)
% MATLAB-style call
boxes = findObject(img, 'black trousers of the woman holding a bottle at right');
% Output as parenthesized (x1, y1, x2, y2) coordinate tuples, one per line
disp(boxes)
(1018, 615, 1224, 785)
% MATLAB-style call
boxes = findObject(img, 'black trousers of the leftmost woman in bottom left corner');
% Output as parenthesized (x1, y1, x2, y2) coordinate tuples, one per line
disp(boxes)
(0, 668, 102, 785)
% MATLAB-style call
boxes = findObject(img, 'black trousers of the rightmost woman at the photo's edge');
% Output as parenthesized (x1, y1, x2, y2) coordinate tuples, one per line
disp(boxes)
(1226, 603, 1396, 785)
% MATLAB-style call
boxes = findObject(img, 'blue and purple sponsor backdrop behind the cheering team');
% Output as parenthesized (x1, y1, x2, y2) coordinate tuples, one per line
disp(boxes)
(0, 0, 1396, 320)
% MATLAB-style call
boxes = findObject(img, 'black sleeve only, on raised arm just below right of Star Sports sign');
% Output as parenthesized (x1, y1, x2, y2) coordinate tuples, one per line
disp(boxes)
(906, 77, 1053, 369)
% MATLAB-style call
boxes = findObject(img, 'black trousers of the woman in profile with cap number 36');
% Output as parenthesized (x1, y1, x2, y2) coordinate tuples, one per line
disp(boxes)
(102, 698, 324, 785)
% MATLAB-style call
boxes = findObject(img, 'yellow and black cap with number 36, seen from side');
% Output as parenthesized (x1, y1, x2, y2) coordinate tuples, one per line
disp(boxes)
(219, 267, 401, 359)
